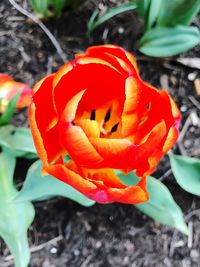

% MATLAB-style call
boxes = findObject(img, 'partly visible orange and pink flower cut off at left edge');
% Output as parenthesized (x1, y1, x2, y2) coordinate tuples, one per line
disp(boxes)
(0, 73, 32, 113)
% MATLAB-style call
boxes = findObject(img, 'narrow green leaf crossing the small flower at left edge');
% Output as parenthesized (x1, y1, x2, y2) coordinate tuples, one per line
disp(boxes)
(0, 90, 21, 126)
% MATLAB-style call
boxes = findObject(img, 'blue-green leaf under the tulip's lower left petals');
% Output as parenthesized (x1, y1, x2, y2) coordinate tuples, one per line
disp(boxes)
(16, 160, 95, 207)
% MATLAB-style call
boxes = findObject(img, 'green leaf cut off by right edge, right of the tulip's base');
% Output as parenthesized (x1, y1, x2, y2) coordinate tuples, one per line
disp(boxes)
(169, 154, 200, 196)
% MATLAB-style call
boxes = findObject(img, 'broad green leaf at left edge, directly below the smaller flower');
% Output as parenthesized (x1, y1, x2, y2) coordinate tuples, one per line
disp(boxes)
(0, 125, 37, 158)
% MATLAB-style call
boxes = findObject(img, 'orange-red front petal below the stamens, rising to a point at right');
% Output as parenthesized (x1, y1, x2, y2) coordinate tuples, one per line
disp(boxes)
(89, 121, 166, 176)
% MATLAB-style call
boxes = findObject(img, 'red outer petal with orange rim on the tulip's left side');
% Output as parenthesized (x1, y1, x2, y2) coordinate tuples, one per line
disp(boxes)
(29, 75, 63, 163)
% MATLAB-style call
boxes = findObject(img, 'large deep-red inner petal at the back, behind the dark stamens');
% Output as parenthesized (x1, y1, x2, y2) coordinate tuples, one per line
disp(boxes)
(54, 58, 124, 115)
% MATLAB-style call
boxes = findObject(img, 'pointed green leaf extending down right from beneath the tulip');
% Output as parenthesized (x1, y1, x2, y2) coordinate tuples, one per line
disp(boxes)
(135, 176, 188, 235)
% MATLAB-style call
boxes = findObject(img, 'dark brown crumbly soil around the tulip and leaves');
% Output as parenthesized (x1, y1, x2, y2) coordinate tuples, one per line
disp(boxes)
(0, 0, 200, 267)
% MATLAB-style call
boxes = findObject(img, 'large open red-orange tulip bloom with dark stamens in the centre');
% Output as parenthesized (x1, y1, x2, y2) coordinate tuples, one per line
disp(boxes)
(29, 45, 180, 203)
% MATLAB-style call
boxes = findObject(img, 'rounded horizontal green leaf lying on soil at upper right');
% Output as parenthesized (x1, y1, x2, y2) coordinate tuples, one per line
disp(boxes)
(139, 25, 200, 57)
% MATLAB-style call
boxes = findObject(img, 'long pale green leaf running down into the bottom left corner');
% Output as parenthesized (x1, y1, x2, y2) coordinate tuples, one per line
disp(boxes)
(0, 151, 34, 267)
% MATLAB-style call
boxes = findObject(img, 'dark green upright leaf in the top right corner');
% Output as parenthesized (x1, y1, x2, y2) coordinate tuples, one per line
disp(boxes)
(157, 0, 200, 26)
